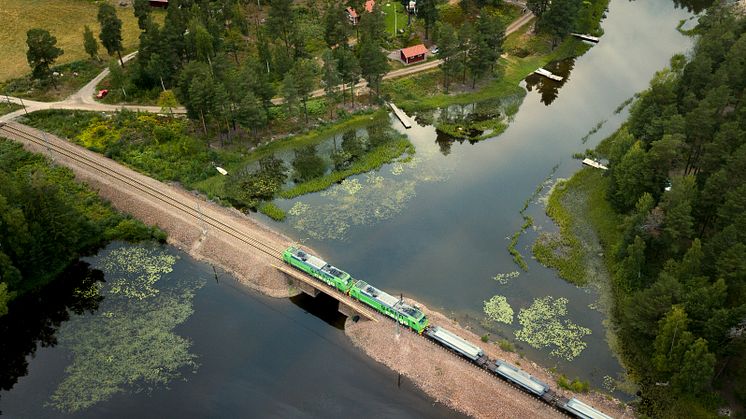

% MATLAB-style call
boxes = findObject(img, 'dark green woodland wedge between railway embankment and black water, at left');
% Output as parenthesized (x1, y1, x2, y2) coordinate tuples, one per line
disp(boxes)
(0, 139, 166, 316)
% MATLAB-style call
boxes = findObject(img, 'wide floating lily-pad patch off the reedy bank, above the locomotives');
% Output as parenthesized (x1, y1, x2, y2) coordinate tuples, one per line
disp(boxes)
(288, 156, 445, 240)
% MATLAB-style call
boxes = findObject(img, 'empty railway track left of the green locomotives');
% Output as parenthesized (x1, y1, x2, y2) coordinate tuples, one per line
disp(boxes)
(0, 123, 284, 261)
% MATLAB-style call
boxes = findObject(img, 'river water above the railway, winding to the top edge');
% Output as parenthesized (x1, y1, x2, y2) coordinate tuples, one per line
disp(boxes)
(268, 0, 692, 394)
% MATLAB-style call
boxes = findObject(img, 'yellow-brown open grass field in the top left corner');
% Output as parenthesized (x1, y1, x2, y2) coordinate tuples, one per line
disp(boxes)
(0, 0, 153, 81)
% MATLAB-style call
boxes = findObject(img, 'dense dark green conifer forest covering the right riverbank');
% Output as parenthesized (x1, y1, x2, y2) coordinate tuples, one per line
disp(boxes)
(597, 7, 746, 417)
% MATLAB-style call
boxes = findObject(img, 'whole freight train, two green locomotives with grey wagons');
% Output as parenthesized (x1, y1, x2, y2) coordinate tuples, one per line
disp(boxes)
(282, 246, 611, 419)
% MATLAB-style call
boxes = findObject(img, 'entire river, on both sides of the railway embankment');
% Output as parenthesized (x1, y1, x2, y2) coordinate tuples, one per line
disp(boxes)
(0, 0, 692, 418)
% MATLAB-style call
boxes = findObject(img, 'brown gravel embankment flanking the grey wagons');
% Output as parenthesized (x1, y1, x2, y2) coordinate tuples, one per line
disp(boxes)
(345, 299, 633, 418)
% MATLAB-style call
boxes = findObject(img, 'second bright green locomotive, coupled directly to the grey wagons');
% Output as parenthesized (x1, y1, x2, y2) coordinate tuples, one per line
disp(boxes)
(350, 281, 430, 333)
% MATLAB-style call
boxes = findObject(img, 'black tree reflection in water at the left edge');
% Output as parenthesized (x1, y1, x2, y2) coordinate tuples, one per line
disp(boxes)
(0, 262, 104, 404)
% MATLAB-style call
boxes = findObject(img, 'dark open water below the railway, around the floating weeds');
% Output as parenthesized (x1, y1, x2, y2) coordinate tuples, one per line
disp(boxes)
(0, 244, 462, 418)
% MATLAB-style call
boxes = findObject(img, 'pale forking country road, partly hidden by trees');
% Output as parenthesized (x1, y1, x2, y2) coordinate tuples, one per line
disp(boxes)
(0, 12, 534, 122)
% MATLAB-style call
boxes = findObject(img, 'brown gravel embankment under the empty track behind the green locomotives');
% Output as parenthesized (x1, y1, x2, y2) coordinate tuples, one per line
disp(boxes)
(0, 123, 298, 297)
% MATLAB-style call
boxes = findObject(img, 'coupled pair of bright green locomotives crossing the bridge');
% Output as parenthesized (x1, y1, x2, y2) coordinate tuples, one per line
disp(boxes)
(282, 246, 430, 333)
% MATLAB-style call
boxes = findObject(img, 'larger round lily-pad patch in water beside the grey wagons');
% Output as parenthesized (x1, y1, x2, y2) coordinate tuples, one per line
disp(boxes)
(515, 296, 591, 361)
